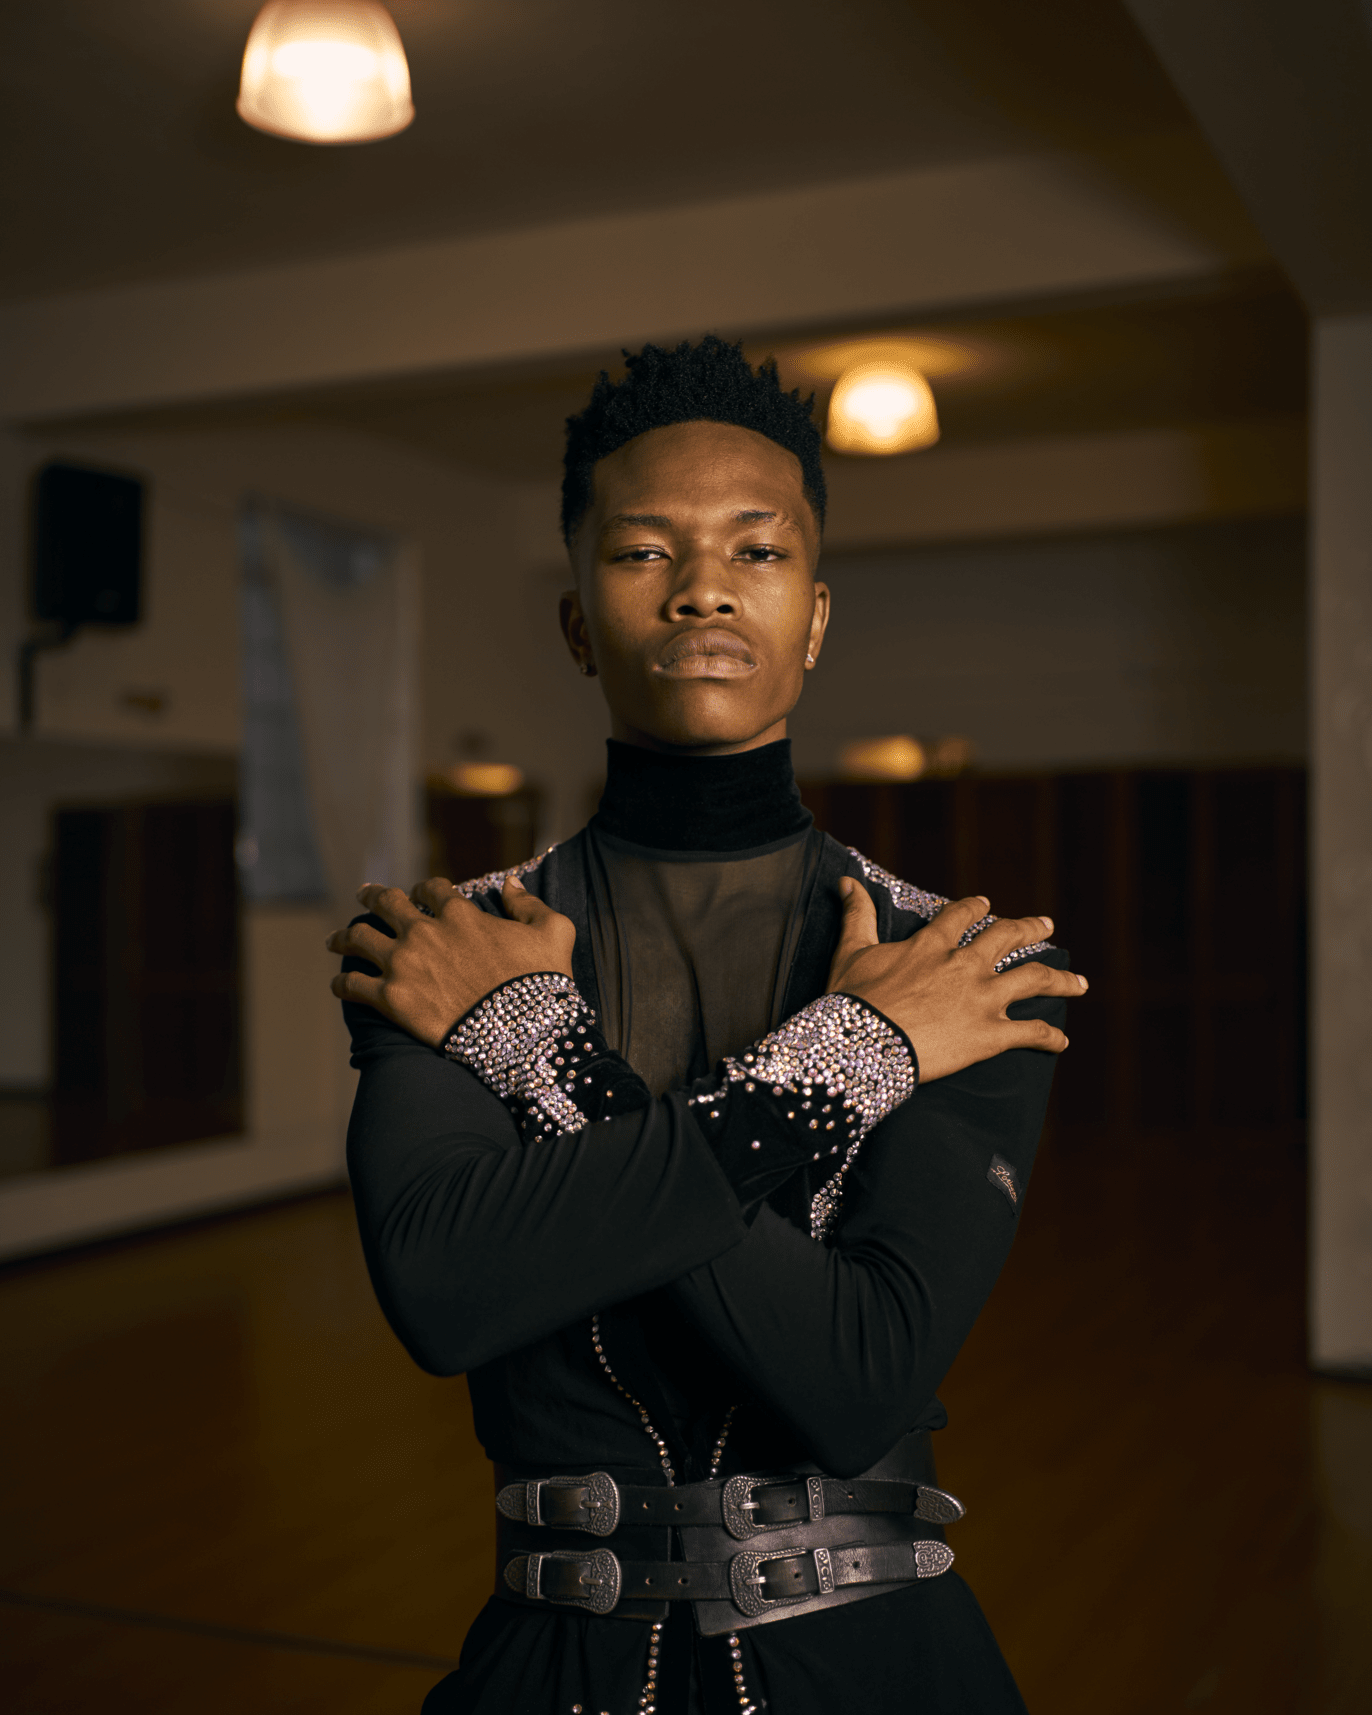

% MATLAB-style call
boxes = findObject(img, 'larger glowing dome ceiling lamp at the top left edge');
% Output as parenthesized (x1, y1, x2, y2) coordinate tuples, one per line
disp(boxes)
(238, 0, 415, 142)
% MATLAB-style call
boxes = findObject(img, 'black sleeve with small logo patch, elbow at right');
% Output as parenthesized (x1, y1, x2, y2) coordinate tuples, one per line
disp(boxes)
(671, 974, 1067, 1477)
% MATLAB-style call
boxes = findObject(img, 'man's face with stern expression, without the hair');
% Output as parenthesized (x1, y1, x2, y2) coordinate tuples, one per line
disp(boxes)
(563, 422, 828, 755)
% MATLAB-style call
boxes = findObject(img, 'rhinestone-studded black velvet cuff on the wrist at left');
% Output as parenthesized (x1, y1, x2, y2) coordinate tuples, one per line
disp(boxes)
(442, 971, 652, 1142)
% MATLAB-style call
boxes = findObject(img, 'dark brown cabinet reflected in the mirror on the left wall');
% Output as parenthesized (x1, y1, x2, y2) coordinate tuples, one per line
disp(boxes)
(51, 799, 244, 1164)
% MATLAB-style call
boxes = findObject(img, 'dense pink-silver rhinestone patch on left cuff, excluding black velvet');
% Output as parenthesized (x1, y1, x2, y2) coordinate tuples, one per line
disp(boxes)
(442, 971, 595, 1135)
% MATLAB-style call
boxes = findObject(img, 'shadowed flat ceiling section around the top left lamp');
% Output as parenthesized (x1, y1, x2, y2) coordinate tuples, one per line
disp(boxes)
(0, 0, 1190, 300)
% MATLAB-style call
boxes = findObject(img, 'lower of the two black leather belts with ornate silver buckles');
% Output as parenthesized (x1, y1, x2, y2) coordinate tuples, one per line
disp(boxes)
(504, 1540, 954, 1619)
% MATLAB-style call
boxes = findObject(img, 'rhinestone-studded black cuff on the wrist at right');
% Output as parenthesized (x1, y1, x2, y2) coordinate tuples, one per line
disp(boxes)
(689, 995, 919, 1238)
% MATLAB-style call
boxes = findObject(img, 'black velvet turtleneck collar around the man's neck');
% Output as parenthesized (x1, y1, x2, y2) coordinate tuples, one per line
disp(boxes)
(592, 739, 815, 852)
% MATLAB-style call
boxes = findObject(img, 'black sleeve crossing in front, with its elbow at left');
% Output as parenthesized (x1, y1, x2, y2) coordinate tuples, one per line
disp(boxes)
(345, 1005, 748, 1375)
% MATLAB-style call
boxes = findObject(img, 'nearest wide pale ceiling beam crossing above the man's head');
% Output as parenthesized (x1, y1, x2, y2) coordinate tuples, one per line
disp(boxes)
(0, 134, 1266, 422)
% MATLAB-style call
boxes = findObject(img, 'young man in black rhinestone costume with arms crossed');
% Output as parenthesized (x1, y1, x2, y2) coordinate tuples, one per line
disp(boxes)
(329, 340, 1086, 1715)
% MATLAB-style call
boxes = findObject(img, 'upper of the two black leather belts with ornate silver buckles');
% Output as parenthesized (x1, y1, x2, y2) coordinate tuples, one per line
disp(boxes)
(496, 1471, 964, 1542)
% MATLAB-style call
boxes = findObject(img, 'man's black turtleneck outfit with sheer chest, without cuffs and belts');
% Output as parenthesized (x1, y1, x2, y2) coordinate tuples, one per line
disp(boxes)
(345, 741, 1065, 1715)
